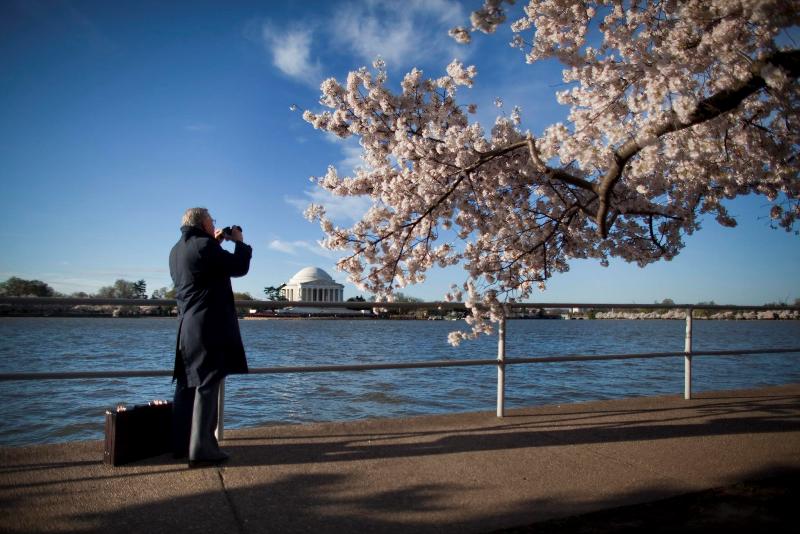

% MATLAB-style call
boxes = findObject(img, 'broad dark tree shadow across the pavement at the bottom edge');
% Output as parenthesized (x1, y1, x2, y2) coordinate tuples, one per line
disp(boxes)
(67, 467, 800, 534)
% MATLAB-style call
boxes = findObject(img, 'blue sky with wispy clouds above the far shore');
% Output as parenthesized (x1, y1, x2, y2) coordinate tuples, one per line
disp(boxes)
(0, 0, 800, 305)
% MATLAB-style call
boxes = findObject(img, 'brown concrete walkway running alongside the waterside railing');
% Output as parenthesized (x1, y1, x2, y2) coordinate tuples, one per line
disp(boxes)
(0, 384, 800, 534)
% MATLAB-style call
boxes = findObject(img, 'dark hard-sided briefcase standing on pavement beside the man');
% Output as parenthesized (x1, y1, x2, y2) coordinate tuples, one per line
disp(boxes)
(103, 401, 172, 466)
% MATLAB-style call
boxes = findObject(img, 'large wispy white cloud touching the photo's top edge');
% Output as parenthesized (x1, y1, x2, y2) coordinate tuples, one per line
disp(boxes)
(331, 0, 469, 68)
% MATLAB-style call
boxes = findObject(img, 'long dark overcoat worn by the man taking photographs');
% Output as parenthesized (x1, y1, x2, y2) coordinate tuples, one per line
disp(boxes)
(169, 226, 253, 387)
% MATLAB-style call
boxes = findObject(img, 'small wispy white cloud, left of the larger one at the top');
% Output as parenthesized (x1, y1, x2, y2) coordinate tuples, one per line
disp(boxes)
(261, 22, 322, 87)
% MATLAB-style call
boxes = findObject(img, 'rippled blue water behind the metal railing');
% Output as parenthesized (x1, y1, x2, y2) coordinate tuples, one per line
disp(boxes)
(0, 318, 800, 445)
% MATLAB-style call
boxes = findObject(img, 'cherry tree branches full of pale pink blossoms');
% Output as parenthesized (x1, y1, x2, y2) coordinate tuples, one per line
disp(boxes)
(303, 0, 800, 343)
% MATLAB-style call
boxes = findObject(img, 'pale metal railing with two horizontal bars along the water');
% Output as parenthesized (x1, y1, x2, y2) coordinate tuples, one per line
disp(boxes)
(0, 297, 800, 439)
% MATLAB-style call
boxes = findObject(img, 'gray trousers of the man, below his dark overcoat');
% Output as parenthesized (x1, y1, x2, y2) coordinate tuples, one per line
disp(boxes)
(173, 377, 220, 460)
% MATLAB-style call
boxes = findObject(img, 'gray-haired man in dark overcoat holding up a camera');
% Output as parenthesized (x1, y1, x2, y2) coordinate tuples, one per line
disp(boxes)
(169, 208, 253, 467)
